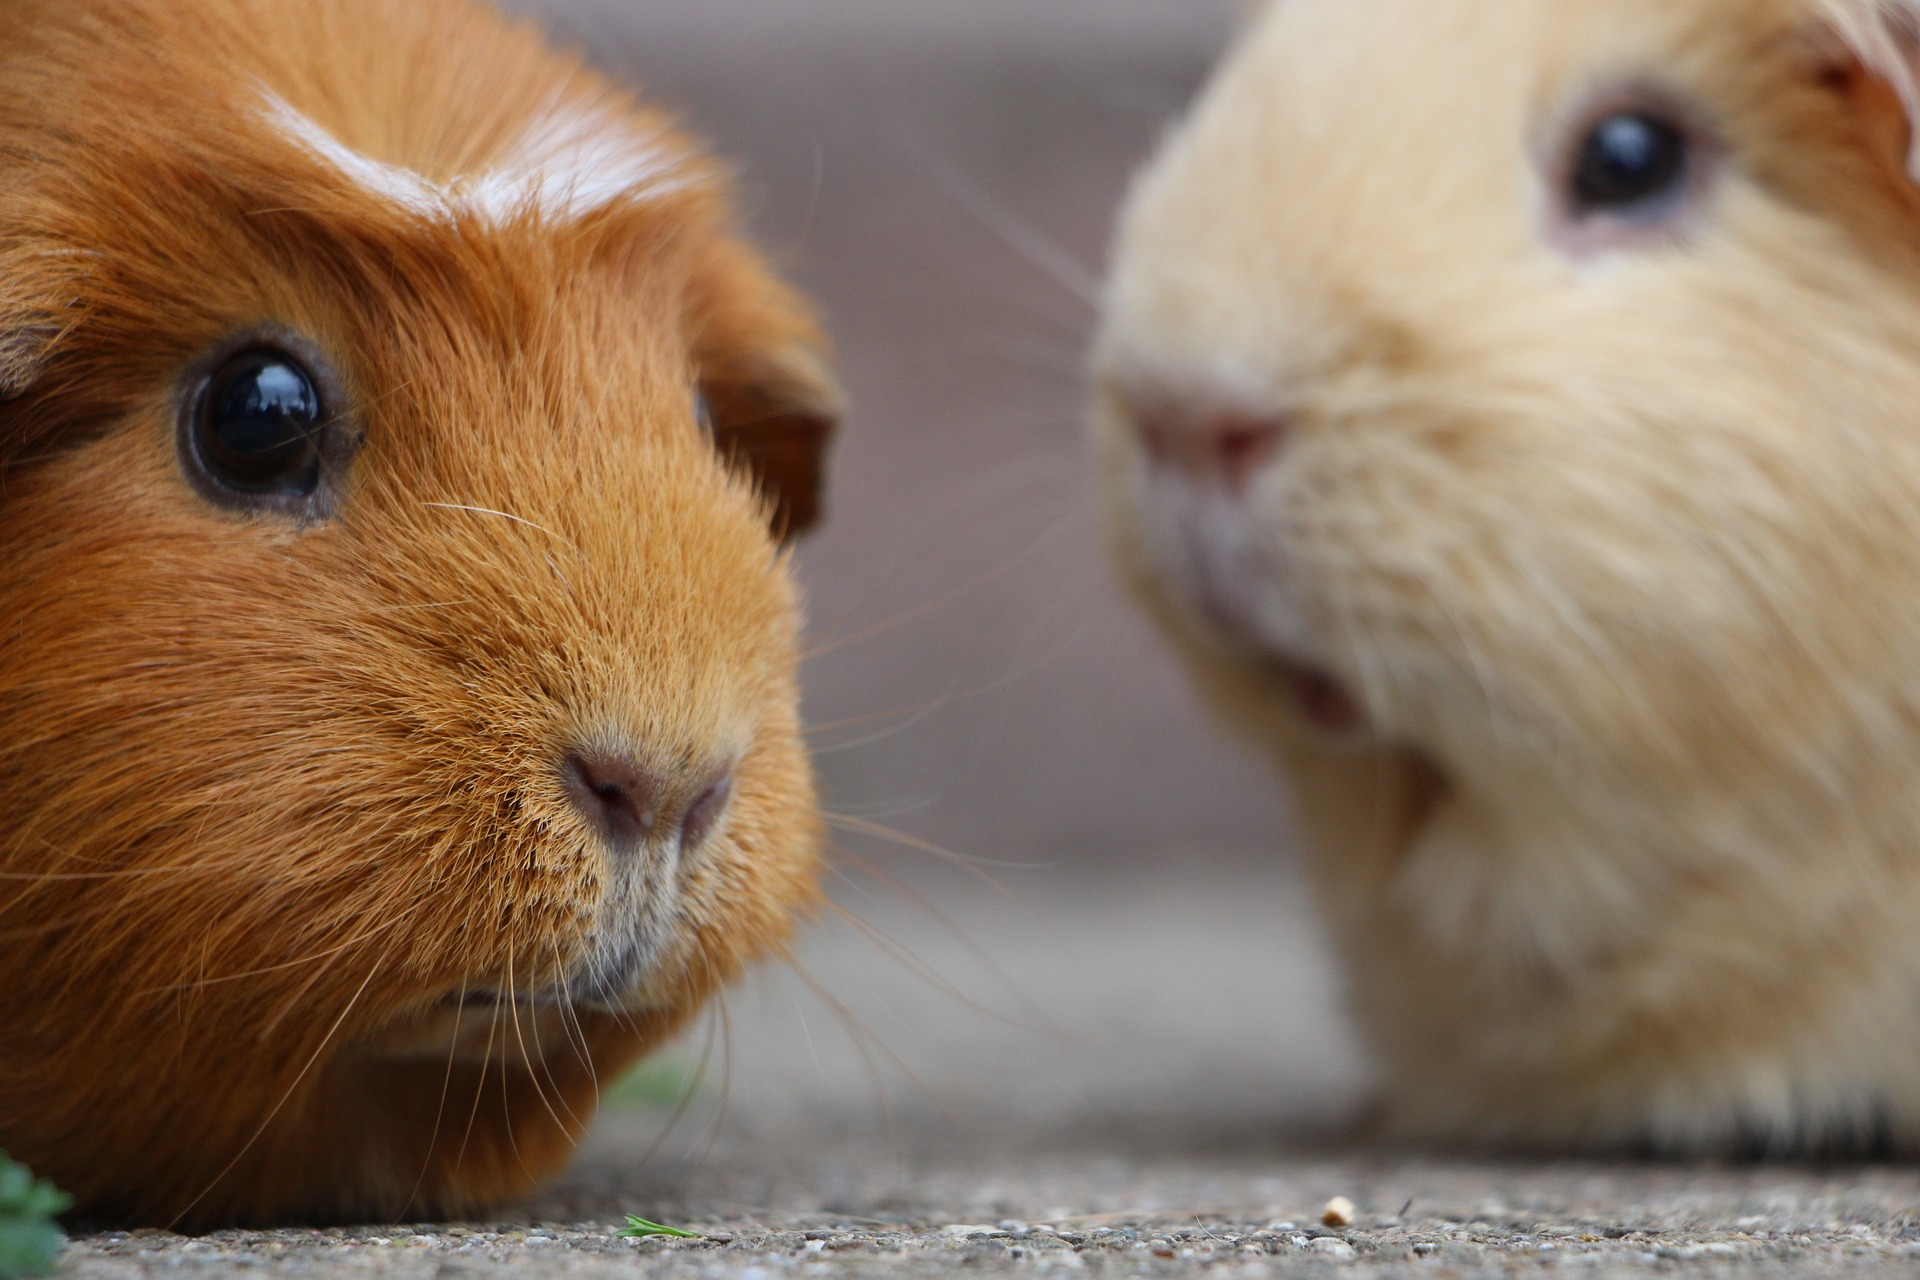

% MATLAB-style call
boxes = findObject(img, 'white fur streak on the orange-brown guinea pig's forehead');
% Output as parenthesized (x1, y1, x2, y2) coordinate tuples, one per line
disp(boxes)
(263, 92, 701, 221)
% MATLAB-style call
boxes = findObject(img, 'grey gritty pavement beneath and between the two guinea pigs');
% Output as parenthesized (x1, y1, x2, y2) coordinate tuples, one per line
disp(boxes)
(63, 860, 1920, 1280)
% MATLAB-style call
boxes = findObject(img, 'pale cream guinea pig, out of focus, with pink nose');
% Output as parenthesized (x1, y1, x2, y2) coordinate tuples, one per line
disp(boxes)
(1096, 0, 1920, 1153)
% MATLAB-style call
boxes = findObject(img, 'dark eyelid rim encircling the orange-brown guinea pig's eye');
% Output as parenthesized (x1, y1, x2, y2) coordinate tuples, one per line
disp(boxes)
(173, 324, 361, 528)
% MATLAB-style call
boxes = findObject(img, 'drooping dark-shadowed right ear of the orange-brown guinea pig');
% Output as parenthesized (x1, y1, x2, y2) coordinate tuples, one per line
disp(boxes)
(701, 347, 841, 539)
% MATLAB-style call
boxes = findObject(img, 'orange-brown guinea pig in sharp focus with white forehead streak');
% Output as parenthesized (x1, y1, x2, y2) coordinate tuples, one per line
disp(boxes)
(0, 0, 835, 1226)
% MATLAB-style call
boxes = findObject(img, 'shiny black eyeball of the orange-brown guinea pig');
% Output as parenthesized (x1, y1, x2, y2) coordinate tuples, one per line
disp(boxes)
(192, 347, 326, 497)
